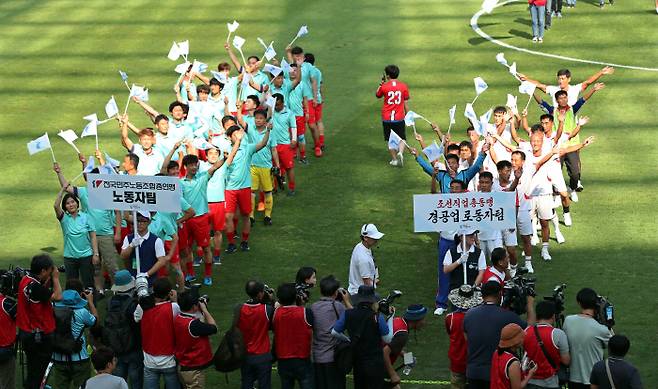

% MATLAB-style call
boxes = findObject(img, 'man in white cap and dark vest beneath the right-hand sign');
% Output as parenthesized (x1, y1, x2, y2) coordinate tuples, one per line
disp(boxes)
(443, 229, 487, 290)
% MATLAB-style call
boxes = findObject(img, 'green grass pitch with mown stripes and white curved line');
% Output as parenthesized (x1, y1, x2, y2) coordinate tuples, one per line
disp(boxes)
(0, 0, 658, 388)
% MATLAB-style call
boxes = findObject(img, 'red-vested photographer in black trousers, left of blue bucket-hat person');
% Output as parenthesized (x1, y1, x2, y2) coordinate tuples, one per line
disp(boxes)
(16, 254, 62, 389)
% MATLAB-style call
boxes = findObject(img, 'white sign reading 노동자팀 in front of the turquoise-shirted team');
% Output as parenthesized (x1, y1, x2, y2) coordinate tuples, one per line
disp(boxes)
(87, 174, 181, 212)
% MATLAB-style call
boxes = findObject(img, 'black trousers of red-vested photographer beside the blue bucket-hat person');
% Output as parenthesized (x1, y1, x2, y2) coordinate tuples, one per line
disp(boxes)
(19, 330, 53, 389)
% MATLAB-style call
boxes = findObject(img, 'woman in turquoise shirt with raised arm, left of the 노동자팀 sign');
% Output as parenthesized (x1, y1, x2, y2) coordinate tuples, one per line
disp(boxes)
(54, 189, 100, 288)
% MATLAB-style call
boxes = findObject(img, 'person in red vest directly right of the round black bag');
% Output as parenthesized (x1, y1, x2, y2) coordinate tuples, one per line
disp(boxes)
(237, 280, 274, 389)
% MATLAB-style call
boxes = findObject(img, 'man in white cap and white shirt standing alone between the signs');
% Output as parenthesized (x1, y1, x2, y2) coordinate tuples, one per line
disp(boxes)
(347, 223, 384, 294)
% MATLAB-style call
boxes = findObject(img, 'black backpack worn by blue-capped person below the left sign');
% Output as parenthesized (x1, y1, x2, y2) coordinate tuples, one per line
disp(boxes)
(102, 297, 136, 355)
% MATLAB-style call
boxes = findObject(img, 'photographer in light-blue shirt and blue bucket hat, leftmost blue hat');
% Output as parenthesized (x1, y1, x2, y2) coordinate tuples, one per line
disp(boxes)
(50, 278, 98, 389)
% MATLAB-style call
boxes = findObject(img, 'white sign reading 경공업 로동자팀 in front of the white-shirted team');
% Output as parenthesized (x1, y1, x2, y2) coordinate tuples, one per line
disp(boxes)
(414, 192, 516, 232)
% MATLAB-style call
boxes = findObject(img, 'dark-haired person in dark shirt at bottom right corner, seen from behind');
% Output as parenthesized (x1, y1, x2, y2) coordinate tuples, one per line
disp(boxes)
(589, 335, 642, 389)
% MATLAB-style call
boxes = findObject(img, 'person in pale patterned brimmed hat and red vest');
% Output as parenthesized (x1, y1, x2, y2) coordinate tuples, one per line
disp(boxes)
(445, 285, 482, 389)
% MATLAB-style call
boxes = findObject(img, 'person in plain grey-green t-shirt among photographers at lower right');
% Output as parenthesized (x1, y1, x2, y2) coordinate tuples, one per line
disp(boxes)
(564, 288, 612, 389)
